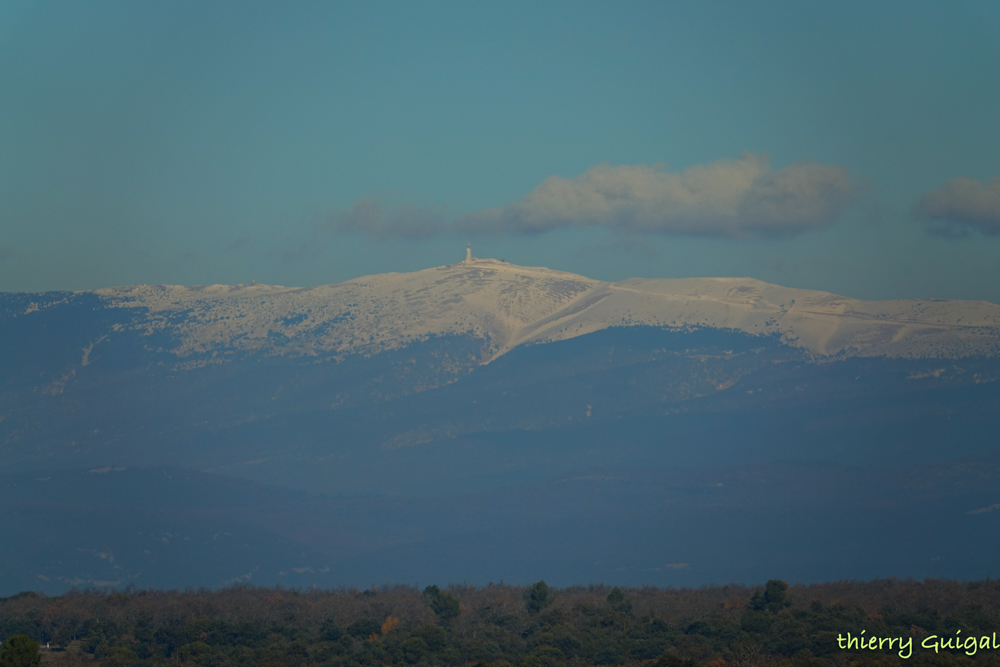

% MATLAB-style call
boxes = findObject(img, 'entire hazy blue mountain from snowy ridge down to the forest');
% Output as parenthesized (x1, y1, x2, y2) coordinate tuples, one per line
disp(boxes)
(0, 259, 1000, 591)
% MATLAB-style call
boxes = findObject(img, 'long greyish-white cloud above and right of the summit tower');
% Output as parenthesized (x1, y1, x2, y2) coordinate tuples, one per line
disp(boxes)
(330, 153, 857, 240)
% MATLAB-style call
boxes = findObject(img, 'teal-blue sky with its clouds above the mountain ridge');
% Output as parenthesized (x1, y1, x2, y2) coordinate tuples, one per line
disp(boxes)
(0, 0, 1000, 303)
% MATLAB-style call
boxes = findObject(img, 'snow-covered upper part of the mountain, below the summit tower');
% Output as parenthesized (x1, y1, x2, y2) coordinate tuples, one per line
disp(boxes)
(58, 259, 1000, 363)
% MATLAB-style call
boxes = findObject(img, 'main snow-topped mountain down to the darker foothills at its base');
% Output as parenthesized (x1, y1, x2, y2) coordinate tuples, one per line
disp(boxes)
(0, 260, 1000, 494)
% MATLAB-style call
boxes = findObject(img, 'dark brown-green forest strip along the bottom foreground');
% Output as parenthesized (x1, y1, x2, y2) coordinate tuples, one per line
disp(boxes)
(0, 579, 1000, 667)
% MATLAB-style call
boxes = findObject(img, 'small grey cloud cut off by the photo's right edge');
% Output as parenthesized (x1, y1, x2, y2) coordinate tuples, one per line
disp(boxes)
(913, 177, 1000, 236)
